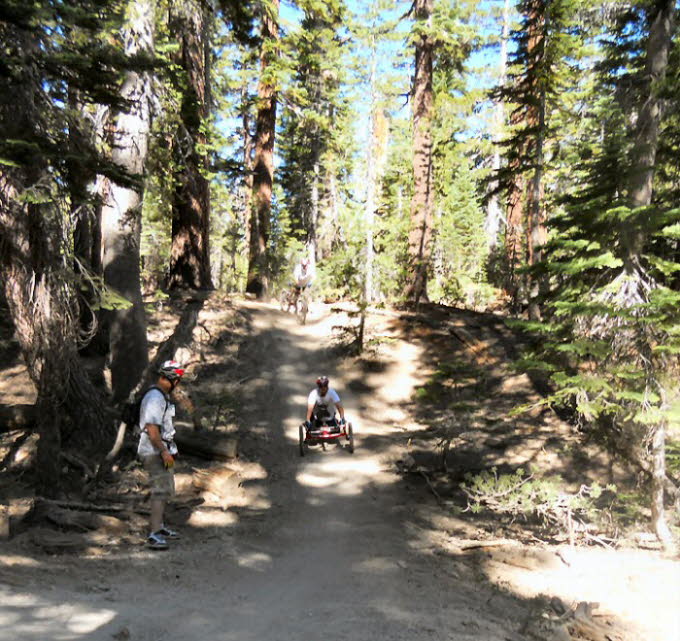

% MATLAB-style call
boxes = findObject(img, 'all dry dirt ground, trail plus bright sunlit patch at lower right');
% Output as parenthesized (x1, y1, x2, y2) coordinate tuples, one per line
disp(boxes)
(0, 303, 680, 641)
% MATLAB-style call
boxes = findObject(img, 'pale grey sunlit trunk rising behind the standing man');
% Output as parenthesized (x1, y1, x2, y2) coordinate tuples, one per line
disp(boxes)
(102, 0, 154, 401)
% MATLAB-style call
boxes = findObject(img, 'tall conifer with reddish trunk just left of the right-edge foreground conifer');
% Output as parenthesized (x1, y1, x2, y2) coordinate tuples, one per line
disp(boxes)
(498, 0, 584, 318)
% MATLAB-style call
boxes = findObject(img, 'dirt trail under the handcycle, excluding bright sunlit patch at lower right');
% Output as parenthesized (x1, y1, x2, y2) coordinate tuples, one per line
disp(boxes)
(0, 303, 672, 641)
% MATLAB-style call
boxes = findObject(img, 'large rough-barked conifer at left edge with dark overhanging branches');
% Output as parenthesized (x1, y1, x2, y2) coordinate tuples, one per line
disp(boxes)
(0, 1, 129, 496)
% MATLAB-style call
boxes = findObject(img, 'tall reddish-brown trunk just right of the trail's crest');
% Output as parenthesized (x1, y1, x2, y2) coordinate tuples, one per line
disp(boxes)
(403, 0, 434, 305)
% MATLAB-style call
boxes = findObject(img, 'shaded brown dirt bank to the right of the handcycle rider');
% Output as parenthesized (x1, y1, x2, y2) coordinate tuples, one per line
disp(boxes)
(382, 305, 613, 493)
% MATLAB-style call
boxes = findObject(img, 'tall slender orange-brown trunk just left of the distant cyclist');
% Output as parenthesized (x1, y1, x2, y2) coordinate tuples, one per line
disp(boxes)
(246, 0, 279, 298)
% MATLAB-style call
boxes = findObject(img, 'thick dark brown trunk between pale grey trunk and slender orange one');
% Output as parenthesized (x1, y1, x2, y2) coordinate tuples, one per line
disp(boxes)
(168, 0, 212, 289)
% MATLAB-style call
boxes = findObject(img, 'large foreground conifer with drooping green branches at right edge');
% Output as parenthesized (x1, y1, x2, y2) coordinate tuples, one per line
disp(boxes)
(516, 2, 680, 544)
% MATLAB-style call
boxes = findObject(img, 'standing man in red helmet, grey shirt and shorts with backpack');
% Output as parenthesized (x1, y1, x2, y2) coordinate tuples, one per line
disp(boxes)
(137, 361, 184, 550)
